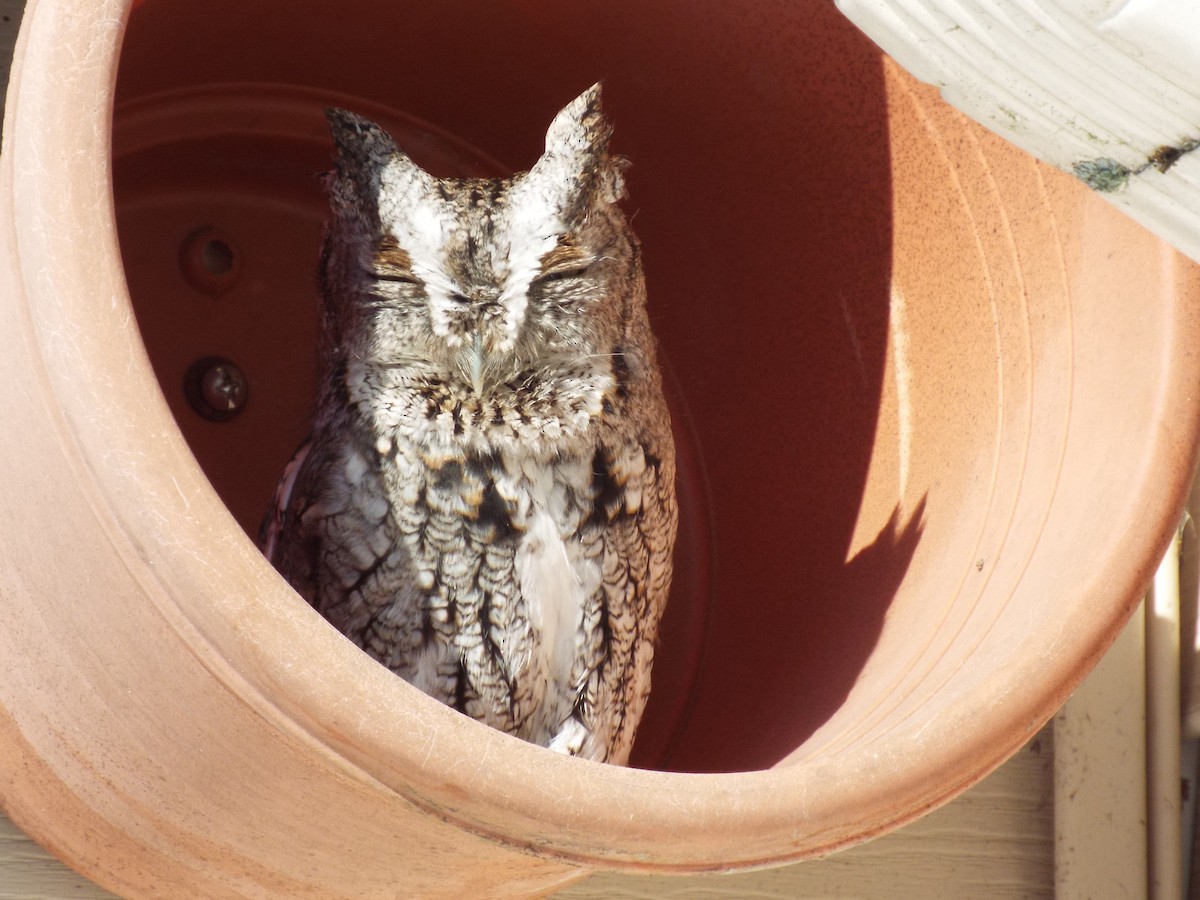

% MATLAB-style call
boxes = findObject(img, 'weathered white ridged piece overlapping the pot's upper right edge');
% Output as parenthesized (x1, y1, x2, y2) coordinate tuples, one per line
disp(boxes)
(838, 0, 1200, 267)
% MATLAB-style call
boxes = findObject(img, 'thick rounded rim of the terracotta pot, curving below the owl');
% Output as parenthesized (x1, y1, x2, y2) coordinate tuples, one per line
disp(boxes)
(0, 0, 1196, 871)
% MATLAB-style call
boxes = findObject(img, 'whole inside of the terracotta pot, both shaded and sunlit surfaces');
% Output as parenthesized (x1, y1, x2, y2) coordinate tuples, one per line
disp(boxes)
(114, 0, 1192, 772)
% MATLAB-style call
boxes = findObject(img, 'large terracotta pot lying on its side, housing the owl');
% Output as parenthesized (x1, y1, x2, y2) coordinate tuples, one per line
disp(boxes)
(0, 0, 1200, 898)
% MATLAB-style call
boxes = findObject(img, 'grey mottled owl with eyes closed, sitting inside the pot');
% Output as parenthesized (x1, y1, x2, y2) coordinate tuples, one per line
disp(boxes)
(263, 85, 677, 763)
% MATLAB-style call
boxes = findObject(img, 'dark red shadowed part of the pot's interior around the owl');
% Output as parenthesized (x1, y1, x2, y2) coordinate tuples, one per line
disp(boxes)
(113, 0, 902, 772)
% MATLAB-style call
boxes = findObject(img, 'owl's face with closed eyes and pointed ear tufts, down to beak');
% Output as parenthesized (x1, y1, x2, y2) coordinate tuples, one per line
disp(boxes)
(329, 86, 623, 394)
